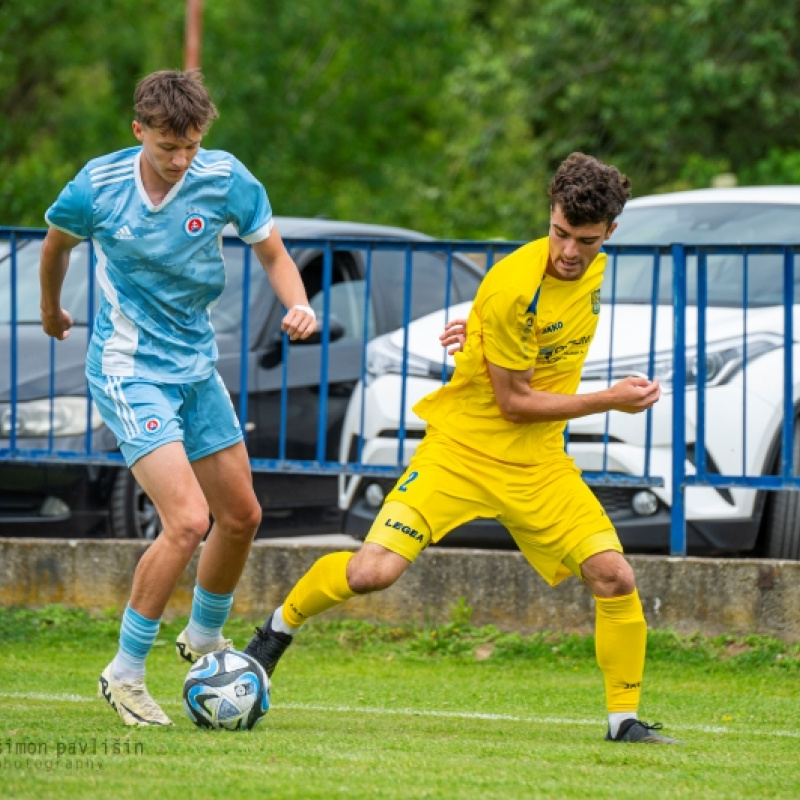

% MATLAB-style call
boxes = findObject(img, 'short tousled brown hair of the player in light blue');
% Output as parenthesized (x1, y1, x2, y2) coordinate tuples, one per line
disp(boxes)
(133, 69, 219, 138)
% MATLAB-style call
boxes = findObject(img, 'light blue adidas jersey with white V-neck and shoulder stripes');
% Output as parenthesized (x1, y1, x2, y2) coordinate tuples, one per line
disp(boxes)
(45, 147, 273, 383)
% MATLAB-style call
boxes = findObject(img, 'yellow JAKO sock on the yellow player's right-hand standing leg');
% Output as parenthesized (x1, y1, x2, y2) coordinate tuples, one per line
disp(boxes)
(594, 589, 647, 714)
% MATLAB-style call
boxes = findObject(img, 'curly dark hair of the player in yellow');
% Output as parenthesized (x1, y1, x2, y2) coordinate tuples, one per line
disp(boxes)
(547, 153, 631, 227)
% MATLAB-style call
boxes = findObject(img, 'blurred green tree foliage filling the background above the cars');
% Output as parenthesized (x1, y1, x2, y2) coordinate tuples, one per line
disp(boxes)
(0, 0, 800, 238)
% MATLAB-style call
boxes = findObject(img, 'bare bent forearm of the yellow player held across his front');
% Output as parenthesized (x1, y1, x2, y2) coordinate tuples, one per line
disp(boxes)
(486, 360, 661, 424)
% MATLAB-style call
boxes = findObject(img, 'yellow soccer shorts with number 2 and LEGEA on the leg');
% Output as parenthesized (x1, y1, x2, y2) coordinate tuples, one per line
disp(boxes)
(367, 427, 622, 586)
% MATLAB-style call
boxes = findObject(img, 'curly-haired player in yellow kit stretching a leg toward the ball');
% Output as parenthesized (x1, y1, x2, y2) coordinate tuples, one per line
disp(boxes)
(247, 153, 678, 744)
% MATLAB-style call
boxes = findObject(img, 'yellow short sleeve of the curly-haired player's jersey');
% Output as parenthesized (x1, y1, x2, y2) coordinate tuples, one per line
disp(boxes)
(481, 284, 539, 372)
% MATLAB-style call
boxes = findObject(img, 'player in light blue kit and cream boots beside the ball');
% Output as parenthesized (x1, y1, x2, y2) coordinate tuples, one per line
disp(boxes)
(40, 71, 316, 725)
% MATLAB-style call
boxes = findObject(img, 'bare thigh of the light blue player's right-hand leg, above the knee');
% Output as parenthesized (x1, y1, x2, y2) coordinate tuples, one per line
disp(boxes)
(192, 441, 261, 528)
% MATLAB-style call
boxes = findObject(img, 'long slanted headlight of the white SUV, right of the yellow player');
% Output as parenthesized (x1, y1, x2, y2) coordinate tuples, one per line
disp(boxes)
(581, 333, 783, 392)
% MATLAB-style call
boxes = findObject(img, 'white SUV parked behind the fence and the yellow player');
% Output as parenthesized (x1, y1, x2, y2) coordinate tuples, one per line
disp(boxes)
(339, 187, 800, 559)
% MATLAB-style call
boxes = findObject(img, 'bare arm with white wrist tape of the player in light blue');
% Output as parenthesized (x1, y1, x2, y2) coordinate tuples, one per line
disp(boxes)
(253, 225, 317, 340)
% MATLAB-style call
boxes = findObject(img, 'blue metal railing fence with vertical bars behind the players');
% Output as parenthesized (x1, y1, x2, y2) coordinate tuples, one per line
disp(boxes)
(0, 228, 800, 555)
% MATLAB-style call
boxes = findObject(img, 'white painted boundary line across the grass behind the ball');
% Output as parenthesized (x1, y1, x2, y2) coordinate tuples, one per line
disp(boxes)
(0, 692, 800, 739)
